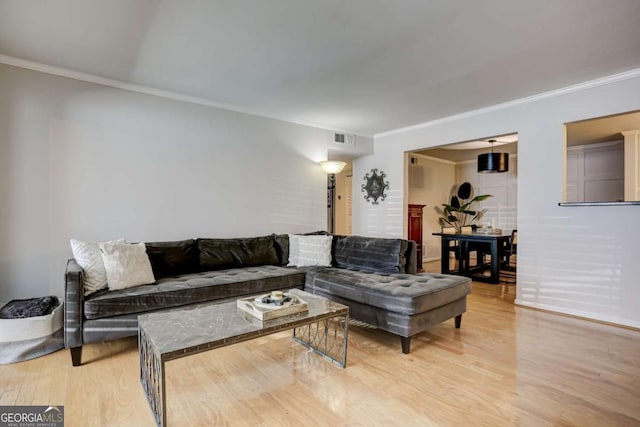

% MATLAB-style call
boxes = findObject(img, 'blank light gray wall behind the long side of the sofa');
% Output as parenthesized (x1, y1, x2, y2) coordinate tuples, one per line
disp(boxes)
(0, 65, 371, 301)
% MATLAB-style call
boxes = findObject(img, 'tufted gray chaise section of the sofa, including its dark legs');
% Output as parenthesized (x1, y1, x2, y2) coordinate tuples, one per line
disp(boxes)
(305, 268, 471, 354)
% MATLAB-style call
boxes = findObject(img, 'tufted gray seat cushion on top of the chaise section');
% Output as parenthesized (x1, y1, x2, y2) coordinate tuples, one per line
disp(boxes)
(305, 268, 471, 315)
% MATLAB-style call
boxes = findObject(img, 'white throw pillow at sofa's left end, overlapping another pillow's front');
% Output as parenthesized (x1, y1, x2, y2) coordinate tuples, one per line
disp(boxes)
(100, 243, 156, 290)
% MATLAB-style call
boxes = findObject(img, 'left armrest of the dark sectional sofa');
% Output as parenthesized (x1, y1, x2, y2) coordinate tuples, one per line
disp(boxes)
(64, 258, 84, 348)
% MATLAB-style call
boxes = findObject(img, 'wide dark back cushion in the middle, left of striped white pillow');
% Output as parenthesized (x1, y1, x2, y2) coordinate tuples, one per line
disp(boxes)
(198, 236, 280, 271)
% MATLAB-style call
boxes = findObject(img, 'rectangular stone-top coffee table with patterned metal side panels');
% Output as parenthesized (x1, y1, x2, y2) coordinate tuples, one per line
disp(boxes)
(138, 289, 349, 426)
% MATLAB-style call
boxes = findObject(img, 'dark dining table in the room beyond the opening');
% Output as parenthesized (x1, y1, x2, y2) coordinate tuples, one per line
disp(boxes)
(432, 231, 511, 284)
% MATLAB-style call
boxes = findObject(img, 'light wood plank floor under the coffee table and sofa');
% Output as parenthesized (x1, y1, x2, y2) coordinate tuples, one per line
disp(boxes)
(0, 262, 640, 427)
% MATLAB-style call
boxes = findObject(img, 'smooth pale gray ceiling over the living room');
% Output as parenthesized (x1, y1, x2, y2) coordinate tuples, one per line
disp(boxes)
(0, 0, 640, 136)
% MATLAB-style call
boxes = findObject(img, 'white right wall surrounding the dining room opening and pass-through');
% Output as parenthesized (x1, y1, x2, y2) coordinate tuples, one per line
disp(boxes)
(353, 72, 640, 327)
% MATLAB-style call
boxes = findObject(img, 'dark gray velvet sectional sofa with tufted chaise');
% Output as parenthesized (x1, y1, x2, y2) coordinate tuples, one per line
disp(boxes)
(64, 235, 471, 366)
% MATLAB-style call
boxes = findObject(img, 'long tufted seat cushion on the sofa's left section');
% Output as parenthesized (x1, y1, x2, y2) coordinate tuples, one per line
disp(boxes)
(84, 265, 305, 319)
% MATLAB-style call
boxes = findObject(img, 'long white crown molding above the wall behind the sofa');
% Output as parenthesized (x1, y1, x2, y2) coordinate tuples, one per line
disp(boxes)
(0, 54, 373, 139)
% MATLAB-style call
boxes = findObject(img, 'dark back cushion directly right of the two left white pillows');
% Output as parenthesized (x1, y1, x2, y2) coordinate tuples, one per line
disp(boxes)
(145, 239, 198, 279)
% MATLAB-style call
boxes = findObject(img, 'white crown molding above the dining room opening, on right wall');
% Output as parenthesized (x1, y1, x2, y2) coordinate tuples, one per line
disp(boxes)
(373, 68, 640, 139)
